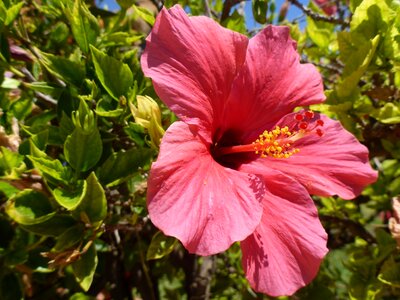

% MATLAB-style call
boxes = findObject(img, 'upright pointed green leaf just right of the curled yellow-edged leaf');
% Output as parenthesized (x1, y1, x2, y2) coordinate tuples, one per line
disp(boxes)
(74, 172, 107, 223)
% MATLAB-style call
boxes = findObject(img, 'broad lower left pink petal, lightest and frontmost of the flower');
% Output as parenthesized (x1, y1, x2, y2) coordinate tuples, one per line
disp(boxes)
(147, 122, 264, 255)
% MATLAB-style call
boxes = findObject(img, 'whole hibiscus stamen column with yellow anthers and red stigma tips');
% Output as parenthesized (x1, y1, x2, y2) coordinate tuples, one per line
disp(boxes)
(214, 111, 324, 158)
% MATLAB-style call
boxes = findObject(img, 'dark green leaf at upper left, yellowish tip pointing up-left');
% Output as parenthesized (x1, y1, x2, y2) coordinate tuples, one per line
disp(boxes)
(36, 49, 86, 86)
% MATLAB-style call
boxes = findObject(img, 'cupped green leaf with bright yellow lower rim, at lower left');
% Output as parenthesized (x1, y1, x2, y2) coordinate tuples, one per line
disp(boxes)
(52, 181, 86, 210)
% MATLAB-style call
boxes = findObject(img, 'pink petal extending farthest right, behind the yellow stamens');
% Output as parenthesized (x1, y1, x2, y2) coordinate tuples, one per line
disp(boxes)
(252, 114, 378, 199)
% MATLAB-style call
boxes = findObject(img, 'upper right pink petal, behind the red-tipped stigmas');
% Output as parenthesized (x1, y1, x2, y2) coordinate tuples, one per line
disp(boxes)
(225, 26, 325, 139)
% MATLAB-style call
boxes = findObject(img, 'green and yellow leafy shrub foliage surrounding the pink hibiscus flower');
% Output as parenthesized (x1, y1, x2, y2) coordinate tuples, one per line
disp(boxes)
(0, 0, 400, 300)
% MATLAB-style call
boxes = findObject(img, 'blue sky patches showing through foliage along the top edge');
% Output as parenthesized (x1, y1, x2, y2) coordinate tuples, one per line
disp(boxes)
(96, 0, 309, 28)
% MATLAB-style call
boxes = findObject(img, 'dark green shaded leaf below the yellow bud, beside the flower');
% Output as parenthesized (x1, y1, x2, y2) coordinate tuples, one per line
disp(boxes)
(96, 149, 152, 186)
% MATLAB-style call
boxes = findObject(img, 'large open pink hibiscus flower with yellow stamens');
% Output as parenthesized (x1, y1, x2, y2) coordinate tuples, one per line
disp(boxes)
(141, 6, 377, 296)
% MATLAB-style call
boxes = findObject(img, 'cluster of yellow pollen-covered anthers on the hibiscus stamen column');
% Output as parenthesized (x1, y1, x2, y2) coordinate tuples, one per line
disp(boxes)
(253, 126, 300, 158)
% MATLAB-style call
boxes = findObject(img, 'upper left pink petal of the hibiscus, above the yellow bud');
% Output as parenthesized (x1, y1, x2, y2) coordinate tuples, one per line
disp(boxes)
(141, 6, 248, 129)
